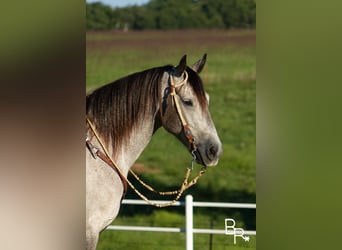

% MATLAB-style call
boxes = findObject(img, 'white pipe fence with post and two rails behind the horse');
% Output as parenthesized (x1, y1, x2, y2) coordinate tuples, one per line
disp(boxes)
(107, 195, 256, 250)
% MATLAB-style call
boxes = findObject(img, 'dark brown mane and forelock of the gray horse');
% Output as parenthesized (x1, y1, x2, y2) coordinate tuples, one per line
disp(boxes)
(86, 65, 207, 157)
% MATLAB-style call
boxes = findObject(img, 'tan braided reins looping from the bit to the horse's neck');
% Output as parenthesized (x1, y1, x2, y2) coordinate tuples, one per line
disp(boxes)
(86, 114, 205, 207)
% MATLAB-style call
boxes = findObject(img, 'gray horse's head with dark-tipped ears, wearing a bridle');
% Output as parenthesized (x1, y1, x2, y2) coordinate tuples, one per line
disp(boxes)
(161, 54, 222, 166)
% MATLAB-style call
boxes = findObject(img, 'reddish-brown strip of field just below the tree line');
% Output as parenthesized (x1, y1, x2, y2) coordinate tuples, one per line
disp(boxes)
(87, 30, 256, 49)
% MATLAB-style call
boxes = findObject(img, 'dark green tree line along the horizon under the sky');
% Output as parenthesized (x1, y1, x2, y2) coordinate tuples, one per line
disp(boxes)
(86, 0, 256, 30)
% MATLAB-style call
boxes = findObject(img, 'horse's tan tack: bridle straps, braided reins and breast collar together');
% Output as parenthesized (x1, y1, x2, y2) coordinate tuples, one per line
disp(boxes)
(86, 71, 206, 207)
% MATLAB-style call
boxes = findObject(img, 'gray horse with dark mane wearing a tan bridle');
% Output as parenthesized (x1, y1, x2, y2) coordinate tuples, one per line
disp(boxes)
(86, 55, 222, 249)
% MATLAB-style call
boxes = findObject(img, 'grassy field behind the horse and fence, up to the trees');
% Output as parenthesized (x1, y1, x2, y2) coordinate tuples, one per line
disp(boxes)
(86, 30, 256, 249)
